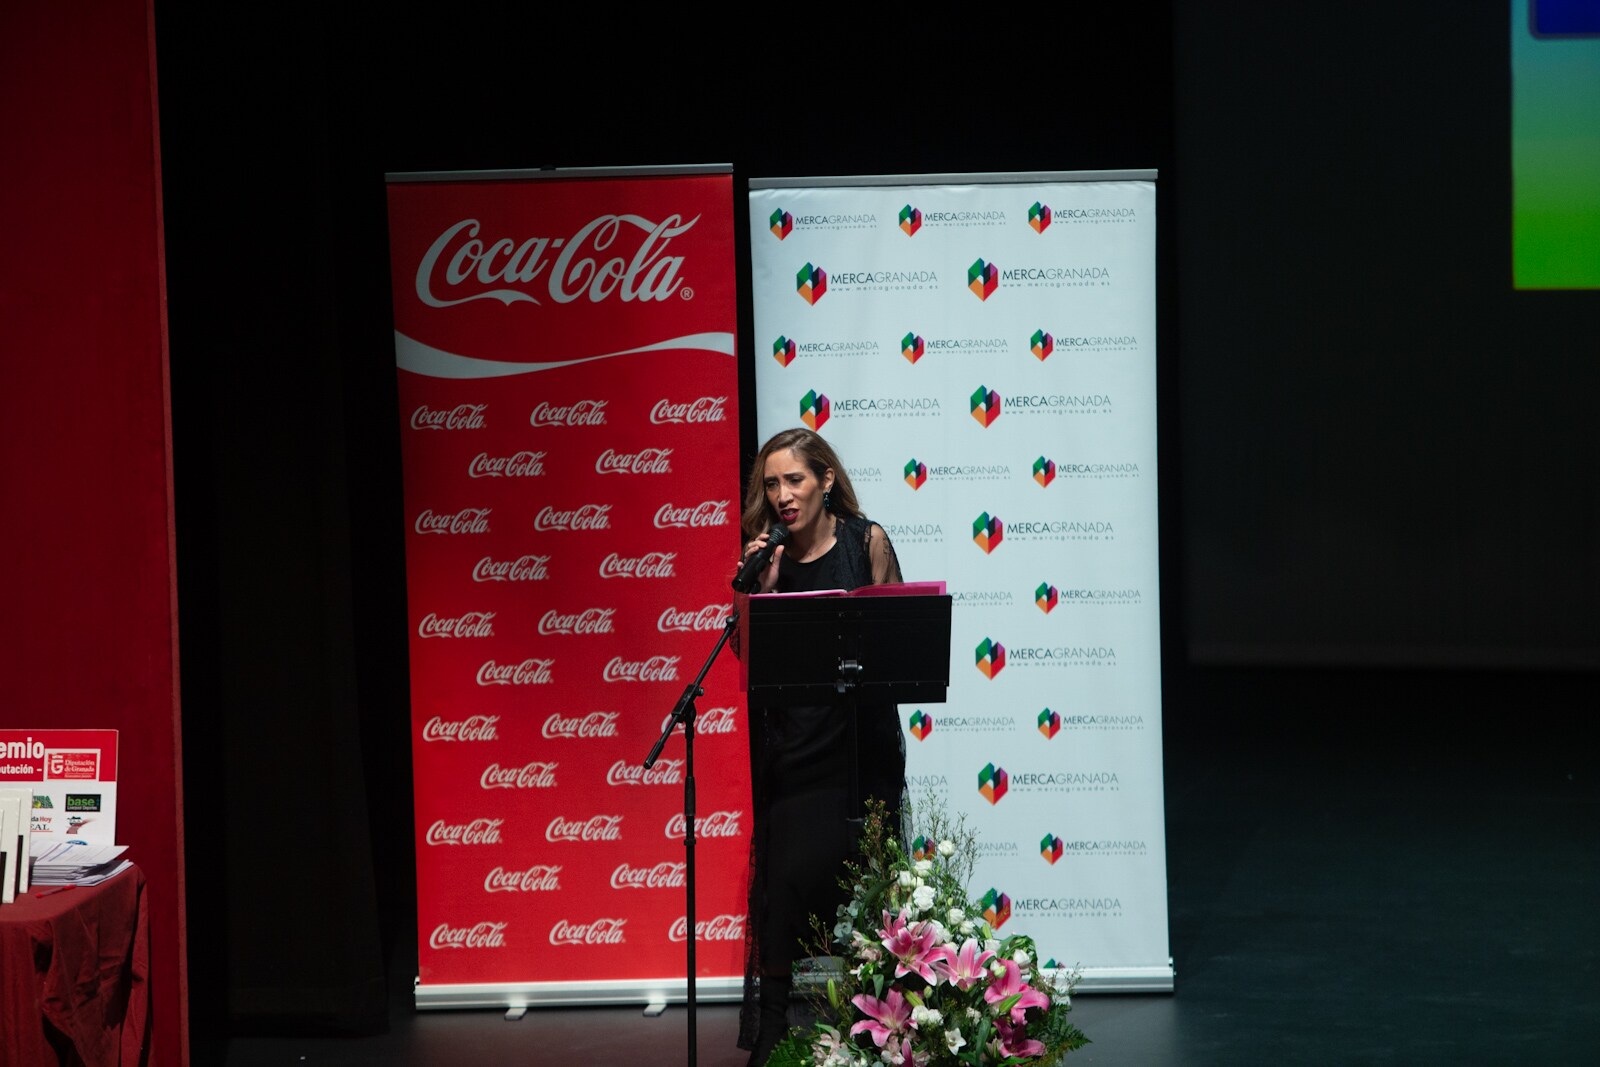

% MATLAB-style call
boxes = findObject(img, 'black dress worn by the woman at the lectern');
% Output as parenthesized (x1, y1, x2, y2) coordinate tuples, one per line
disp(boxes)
(739, 517, 906, 1048)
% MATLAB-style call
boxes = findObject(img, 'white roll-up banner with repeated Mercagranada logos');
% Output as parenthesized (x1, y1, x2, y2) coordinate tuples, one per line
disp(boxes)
(750, 171, 1173, 992)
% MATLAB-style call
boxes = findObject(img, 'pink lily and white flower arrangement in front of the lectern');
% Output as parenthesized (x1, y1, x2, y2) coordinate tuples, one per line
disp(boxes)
(766, 798, 1090, 1067)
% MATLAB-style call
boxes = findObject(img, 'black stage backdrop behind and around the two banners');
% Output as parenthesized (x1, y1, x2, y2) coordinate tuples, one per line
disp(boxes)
(157, 0, 1600, 1062)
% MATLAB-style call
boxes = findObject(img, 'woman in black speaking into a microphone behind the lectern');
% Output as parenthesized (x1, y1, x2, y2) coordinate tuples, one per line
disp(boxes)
(739, 427, 906, 1067)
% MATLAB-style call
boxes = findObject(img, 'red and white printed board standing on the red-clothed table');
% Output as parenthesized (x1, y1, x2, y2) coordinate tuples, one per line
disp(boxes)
(0, 729, 117, 854)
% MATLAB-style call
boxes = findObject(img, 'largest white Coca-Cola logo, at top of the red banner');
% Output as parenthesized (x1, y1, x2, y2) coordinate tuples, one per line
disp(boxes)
(416, 214, 699, 307)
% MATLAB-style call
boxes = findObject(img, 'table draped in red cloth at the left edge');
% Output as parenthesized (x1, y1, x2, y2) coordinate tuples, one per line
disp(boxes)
(0, 867, 150, 1067)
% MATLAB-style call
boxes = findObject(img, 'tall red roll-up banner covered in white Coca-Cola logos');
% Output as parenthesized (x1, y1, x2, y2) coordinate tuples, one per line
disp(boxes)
(389, 168, 750, 1006)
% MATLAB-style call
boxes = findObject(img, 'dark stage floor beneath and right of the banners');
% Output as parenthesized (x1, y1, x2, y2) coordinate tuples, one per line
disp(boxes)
(212, 672, 1600, 1067)
